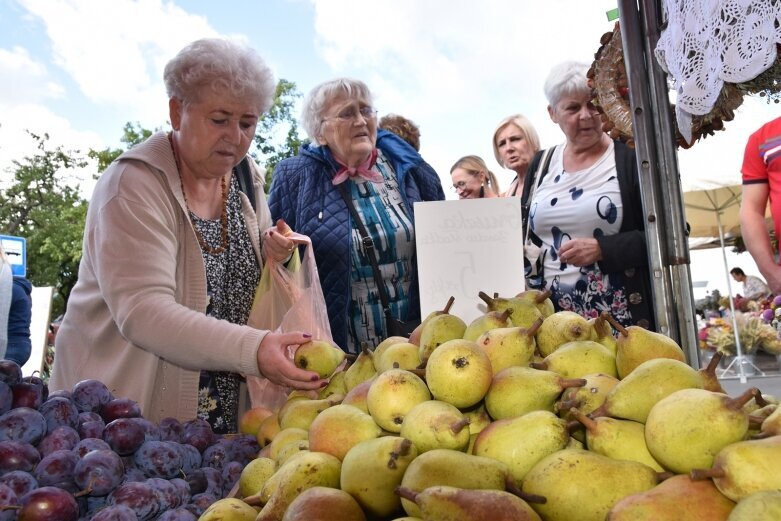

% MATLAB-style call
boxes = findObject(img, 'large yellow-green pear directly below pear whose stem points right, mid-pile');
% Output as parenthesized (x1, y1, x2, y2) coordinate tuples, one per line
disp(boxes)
(472, 411, 569, 483)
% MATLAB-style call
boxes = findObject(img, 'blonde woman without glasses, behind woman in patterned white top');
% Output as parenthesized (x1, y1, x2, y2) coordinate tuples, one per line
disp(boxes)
(493, 114, 540, 197)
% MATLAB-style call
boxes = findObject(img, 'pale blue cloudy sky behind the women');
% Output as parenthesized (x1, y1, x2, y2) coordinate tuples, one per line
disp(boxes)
(0, 0, 781, 292)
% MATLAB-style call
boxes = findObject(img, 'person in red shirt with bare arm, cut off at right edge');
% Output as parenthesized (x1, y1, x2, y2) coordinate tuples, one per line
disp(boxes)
(740, 117, 781, 294)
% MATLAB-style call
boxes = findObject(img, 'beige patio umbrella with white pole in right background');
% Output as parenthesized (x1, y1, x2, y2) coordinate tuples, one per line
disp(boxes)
(683, 185, 768, 383)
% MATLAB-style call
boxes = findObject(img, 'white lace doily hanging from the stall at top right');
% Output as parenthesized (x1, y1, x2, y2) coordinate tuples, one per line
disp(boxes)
(655, 0, 781, 143)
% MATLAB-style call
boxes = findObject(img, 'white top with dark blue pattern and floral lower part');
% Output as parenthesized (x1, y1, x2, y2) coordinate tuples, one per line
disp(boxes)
(529, 142, 632, 325)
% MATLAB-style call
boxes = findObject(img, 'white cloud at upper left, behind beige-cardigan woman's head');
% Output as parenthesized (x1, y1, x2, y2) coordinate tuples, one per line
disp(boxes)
(20, 0, 217, 126)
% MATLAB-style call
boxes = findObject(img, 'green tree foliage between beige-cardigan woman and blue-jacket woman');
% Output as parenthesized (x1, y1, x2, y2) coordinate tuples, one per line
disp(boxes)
(255, 79, 302, 192)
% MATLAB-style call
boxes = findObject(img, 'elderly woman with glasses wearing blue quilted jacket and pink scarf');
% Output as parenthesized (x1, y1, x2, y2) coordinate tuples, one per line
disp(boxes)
(269, 78, 445, 353)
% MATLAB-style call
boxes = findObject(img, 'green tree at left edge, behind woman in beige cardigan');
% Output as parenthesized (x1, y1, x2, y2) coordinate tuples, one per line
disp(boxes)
(0, 133, 87, 316)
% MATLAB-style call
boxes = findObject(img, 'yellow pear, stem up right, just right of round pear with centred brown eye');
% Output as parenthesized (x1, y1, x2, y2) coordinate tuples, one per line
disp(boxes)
(475, 318, 542, 374)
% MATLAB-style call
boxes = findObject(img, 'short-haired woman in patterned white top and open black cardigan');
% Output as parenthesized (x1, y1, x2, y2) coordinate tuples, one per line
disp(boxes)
(521, 62, 654, 329)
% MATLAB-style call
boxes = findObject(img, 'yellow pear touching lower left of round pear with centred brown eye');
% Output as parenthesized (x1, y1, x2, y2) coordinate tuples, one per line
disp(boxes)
(366, 369, 431, 434)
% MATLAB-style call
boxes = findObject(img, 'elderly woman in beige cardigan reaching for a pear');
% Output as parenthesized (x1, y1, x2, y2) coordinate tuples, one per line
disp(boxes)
(50, 39, 325, 432)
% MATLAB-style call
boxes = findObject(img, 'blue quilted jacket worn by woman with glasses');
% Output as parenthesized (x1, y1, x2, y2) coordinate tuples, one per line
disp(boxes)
(268, 130, 445, 349)
